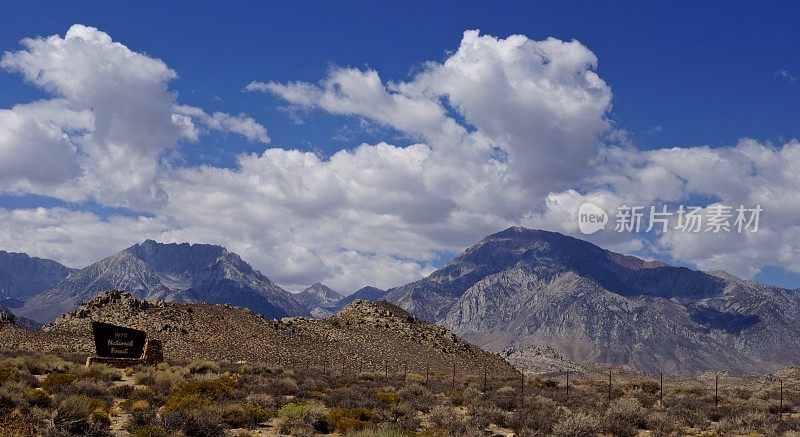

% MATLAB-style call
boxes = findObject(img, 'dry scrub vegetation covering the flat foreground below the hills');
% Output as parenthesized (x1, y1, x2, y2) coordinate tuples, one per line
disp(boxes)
(0, 354, 800, 437)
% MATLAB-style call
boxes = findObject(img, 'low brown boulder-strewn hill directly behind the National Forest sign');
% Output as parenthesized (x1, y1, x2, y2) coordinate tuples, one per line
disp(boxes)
(0, 291, 515, 375)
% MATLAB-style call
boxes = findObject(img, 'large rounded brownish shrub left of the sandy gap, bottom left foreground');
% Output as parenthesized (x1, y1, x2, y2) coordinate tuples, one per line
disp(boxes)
(53, 395, 111, 435)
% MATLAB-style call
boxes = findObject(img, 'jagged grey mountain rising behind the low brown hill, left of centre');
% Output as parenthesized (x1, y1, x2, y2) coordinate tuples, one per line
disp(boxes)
(15, 240, 307, 322)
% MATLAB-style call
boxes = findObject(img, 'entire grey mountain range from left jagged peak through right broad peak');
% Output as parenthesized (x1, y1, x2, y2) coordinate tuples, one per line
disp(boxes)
(6, 227, 800, 373)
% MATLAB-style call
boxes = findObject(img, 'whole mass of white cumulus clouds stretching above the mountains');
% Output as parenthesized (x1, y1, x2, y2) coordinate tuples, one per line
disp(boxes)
(0, 25, 800, 291)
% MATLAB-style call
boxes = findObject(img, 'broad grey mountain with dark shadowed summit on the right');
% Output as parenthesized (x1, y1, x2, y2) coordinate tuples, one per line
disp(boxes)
(387, 227, 800, 372)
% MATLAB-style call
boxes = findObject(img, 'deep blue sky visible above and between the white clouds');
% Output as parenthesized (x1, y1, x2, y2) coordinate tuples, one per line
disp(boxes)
(0, 1, 800, 287)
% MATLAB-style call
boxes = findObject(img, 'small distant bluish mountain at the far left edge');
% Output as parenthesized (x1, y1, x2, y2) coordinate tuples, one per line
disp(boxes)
(0, 250, 72, 306)
